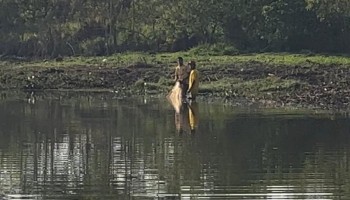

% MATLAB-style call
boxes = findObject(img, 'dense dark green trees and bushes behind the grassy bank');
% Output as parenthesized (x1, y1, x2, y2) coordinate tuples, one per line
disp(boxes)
(0, 0, 350, 58)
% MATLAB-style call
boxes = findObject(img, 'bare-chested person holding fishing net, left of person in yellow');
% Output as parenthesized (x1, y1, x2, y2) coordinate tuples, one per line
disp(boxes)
(175, 57, 190, 99)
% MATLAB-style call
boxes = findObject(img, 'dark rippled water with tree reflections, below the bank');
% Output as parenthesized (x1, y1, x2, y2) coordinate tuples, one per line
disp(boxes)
(0, 93, 350, 199)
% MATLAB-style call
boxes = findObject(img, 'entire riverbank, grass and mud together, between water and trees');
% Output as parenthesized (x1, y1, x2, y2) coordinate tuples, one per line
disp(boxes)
(0, 52, 350, 109)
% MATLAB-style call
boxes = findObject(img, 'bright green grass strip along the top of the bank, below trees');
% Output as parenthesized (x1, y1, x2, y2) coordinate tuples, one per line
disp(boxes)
(0, 49, 350, 69)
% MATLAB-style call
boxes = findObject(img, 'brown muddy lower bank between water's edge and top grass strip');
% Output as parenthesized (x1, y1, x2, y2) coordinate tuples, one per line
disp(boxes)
(0, 62, 350, 109)
